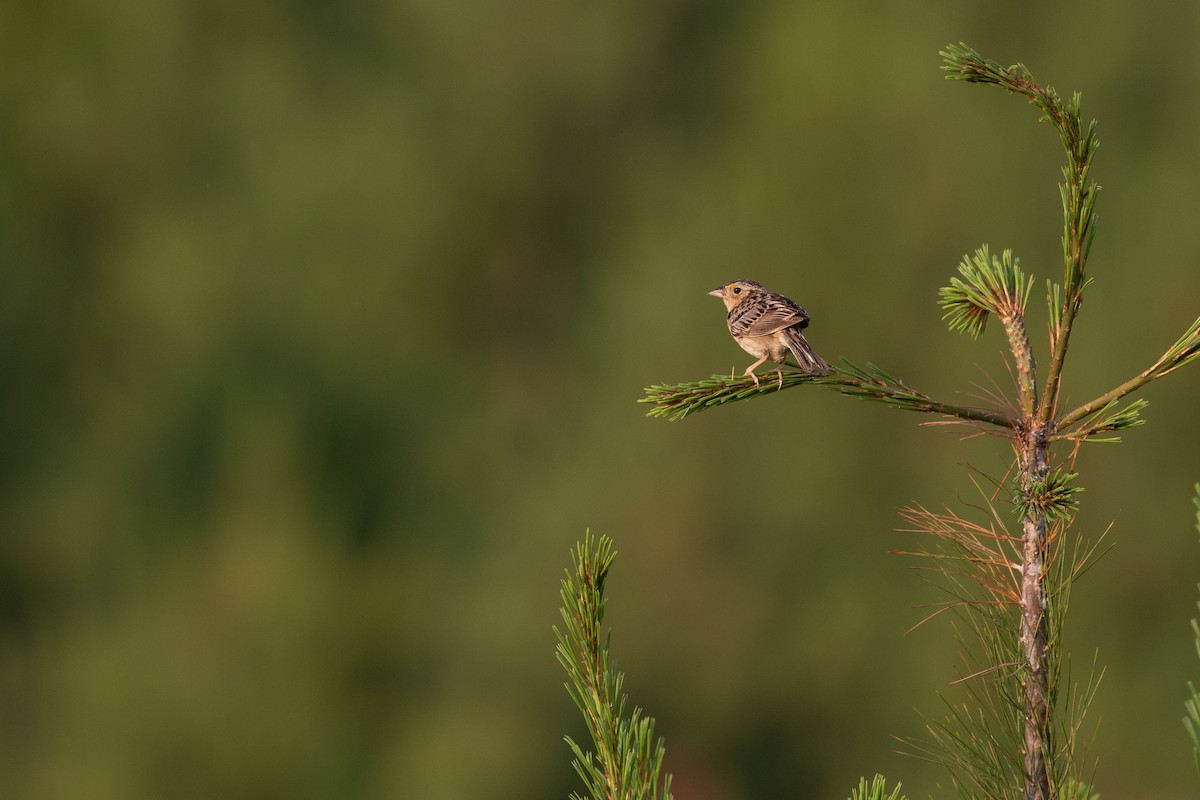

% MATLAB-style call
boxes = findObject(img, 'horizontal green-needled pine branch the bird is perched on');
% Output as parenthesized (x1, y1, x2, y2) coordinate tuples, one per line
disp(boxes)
(638, 359, 1015, 429)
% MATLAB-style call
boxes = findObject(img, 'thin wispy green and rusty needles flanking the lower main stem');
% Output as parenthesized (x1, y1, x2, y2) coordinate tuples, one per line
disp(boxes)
(900, 481, 1099, 800)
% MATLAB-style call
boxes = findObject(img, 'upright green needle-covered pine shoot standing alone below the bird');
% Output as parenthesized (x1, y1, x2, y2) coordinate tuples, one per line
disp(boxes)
(554, 531, 671, 800)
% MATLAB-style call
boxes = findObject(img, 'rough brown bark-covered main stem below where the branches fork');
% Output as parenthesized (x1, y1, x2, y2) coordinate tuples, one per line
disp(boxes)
(1020, 427, 1052, 800)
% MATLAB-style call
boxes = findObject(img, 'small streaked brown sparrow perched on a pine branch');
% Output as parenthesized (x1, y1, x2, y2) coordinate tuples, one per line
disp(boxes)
(708, 281, 829, 389)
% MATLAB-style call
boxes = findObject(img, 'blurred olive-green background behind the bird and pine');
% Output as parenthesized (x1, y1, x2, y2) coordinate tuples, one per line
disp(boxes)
(0, 0, 1200, 800)
